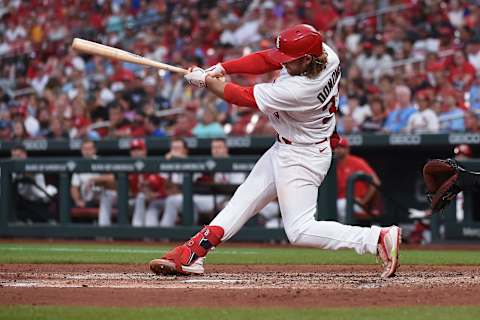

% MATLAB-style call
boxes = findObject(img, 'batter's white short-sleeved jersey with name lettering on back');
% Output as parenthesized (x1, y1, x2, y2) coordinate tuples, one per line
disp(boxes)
(253, 43, 341, 144)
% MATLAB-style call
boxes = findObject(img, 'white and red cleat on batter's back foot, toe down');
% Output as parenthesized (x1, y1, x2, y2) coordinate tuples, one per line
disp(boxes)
(377, 226, 402, 278)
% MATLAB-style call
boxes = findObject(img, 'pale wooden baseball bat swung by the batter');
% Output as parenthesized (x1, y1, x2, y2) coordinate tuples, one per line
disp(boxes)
(72, 38, 188, 74)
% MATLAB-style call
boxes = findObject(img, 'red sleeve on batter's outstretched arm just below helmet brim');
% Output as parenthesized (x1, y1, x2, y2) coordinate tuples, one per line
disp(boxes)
(222, 50, 282, 74)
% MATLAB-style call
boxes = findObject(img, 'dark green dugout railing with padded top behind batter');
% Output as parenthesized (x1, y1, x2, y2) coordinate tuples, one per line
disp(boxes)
(0, 156, 336, 241)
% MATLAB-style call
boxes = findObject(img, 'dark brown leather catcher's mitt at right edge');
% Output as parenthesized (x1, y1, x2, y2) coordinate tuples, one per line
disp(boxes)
(423, 159, 462, 212)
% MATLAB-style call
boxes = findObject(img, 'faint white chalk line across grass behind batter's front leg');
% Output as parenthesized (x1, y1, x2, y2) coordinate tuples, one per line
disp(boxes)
(0, 246, 260, 255)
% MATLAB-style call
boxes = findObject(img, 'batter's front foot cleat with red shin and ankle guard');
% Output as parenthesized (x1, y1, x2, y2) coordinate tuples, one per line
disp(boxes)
(150, 226, 224, 275)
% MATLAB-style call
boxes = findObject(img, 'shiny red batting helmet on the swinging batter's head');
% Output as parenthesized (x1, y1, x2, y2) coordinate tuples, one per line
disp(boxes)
(267, 24, 323, 63)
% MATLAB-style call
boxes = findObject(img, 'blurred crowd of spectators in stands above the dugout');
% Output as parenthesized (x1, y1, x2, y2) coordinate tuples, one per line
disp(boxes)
(0, 0, 480, 140)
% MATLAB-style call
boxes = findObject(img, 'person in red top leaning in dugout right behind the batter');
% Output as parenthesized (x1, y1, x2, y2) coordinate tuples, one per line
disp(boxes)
(335, 138, 380, 222)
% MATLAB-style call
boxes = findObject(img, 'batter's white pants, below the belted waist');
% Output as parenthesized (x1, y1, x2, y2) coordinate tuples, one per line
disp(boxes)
(210, 141, 380, 254)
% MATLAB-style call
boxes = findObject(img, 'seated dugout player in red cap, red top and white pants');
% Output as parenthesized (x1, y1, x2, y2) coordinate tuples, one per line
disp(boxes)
(128, 139, 167, 227)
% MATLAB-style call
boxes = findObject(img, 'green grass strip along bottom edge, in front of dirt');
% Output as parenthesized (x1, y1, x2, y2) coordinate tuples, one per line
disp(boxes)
(0, 306, 480, 320)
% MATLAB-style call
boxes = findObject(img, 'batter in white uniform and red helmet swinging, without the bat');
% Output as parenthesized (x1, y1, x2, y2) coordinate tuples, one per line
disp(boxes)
(150, 24, 401, 277)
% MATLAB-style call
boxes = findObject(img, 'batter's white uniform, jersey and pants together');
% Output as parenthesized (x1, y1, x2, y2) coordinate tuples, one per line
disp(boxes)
(210, 44, 380, 254)
